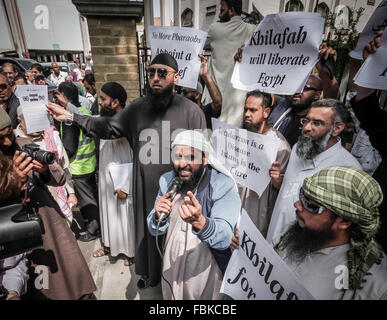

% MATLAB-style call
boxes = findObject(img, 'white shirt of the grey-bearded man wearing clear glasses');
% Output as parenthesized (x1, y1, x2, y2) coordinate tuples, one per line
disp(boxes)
(266, 140, 361, 243)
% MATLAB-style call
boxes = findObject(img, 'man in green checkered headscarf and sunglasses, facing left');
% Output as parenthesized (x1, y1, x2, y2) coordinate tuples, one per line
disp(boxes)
(274, 166, 387, 300)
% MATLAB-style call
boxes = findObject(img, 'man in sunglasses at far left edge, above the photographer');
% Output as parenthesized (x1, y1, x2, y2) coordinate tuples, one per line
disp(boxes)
(0, 72, 20, 129)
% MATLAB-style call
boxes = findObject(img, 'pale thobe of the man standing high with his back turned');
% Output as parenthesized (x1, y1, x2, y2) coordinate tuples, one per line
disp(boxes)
(202, 16, 256, 127)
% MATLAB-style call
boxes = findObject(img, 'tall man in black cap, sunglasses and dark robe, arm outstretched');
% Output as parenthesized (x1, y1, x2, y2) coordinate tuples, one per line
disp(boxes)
(47, 53, 206, 289)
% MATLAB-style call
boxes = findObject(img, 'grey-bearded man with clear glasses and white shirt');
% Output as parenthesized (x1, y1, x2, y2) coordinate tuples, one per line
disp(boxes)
(267, 99, 361, 242)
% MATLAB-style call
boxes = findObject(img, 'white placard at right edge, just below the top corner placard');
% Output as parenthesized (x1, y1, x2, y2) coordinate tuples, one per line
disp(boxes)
(353, 32, 387, 90)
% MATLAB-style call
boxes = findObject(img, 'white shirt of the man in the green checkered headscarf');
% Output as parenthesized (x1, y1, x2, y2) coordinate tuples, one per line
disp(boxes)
(280, 244, 387, 300)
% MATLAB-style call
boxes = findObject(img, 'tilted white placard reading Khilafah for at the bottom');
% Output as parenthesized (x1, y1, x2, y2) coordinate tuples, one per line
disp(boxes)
(220, 210, 314, 300)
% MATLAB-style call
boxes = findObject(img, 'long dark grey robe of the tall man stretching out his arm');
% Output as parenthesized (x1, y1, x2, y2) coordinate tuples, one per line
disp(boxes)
(74, 94, 206, 286)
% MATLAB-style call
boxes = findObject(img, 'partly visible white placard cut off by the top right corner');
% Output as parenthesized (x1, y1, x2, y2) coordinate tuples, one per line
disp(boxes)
(349, 0, 387, 60)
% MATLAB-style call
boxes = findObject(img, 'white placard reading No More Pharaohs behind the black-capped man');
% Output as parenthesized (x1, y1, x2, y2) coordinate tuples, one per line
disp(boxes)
(148, 26, 207, 89)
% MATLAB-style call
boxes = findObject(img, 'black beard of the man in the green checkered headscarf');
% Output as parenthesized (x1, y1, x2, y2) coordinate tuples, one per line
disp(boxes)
(284, 221, 335, 262)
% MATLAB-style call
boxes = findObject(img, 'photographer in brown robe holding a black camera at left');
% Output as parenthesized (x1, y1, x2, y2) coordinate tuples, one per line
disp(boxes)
(0, 108, 96, 300)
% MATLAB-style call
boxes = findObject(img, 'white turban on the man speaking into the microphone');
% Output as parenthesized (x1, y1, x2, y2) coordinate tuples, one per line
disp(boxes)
(172, 130, 234, 179)
